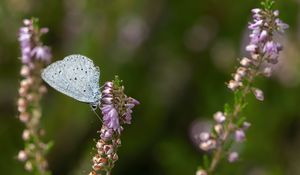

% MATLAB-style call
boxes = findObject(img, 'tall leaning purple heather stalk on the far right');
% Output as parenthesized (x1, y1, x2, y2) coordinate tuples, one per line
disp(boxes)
(196, 0, 288, 175)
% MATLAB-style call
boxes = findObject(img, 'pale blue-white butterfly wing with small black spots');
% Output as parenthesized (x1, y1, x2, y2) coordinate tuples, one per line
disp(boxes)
(42, 55, 100, 103)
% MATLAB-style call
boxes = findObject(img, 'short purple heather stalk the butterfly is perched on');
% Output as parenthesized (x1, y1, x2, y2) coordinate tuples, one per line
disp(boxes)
(89, 76, 139, 175)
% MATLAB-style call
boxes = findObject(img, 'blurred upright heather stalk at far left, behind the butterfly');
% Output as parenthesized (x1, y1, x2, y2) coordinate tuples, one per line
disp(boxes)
(17, 18, 52, 175)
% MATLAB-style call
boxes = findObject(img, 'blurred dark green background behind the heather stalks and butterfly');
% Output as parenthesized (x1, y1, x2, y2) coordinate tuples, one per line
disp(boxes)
(0, 0, 300, 175)
